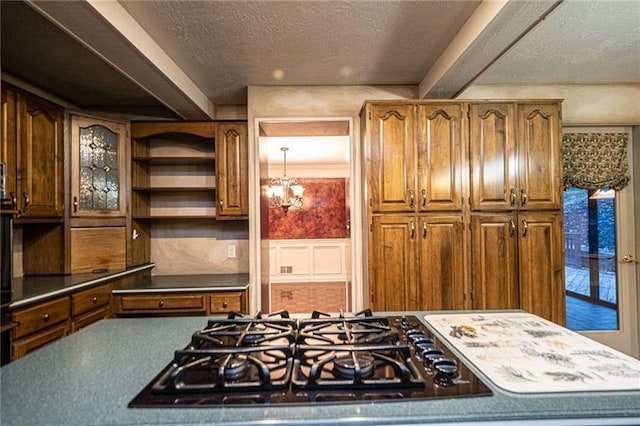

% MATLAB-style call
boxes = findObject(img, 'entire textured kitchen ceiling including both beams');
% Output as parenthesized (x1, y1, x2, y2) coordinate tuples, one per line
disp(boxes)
(0, 0, 640, 120)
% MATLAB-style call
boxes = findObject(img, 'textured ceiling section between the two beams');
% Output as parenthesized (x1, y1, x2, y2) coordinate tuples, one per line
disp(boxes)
(120, 0, 479, 104)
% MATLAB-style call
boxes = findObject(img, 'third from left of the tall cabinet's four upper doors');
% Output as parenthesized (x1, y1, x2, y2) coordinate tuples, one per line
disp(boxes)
(469, 103, 518, 210)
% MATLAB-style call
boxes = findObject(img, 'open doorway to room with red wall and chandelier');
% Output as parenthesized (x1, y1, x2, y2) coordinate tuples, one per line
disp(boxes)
(256, 119, 356, 313)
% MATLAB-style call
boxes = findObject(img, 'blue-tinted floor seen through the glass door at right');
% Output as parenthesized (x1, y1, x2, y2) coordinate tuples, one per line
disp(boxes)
(565, 266, 618, 331)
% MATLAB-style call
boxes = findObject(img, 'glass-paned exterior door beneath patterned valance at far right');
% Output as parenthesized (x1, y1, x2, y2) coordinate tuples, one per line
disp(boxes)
(564, 127, 638, 357)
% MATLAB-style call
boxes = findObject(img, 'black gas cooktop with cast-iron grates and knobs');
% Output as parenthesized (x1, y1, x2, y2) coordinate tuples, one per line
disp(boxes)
(129, 310, 491, 408)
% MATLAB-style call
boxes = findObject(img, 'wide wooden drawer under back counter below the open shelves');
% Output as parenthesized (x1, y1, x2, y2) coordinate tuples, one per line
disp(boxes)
(118, 294, 206, 313)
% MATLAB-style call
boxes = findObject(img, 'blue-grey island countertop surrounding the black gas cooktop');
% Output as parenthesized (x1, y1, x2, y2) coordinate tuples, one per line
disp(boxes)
(0, 312, 640, 425)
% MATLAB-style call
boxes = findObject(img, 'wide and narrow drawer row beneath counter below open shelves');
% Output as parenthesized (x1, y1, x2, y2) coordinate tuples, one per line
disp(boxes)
(113, 291, 248, 315)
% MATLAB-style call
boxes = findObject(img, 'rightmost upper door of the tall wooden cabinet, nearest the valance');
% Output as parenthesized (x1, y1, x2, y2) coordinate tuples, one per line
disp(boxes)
(518, 103, 562, 210)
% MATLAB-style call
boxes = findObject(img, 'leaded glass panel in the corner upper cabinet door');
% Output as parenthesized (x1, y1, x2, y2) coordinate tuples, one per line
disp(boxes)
(79, 124, 120, 210)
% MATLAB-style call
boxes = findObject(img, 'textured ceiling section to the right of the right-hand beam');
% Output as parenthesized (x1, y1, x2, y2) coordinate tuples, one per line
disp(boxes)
(475, 0, 640, 84)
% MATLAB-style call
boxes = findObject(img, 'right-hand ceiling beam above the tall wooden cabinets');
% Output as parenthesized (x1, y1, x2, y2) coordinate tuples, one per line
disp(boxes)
(418, 0, 562, 99)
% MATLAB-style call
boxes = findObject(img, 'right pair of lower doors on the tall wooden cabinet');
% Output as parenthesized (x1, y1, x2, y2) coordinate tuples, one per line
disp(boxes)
(471, 213, 565, 325)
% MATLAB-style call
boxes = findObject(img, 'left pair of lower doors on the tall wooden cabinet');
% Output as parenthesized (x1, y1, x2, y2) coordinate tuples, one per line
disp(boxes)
(369, 214, 464, 311)
